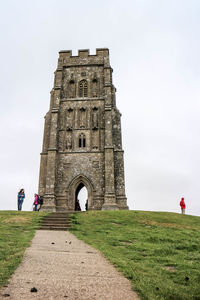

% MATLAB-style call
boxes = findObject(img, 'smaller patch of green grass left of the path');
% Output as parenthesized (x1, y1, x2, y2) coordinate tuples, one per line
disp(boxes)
(0, 211, 46, 287)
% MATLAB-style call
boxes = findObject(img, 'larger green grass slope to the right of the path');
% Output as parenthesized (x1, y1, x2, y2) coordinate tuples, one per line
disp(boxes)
(71, 211, 200, 300)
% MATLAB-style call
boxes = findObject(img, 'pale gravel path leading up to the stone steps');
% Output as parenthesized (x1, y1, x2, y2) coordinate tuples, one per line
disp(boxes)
(0, 230, 139, 300)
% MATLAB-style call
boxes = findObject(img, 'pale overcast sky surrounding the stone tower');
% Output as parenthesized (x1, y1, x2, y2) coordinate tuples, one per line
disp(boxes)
(0, 0, 200, 215)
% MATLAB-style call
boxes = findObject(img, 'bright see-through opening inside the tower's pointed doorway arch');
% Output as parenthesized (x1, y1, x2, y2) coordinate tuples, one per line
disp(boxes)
(75, 182, 88, 211)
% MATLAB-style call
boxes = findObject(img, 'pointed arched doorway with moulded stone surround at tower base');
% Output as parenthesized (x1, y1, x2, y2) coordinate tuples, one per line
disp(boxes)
(68, 175, 94, 211)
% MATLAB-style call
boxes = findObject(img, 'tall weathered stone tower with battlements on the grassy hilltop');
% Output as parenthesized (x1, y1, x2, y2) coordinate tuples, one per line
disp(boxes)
(39, 48, 128, 211)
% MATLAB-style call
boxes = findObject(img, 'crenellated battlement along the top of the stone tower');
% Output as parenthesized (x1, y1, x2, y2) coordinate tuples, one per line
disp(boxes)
(59, 48, 109, 58)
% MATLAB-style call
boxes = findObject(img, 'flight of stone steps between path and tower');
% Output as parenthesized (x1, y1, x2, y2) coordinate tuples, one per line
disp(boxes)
(40, 212, 71, 230)
